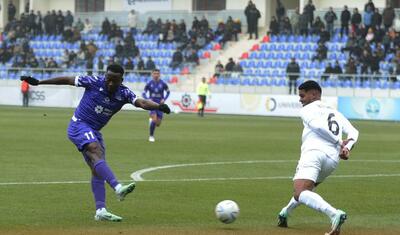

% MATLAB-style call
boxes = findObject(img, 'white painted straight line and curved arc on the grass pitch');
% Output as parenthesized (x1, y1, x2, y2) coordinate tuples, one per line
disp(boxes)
(0, 160, 400, 186)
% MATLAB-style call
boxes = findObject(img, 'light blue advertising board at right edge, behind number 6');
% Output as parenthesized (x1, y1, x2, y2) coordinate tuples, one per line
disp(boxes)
(338, 97, 400, 121)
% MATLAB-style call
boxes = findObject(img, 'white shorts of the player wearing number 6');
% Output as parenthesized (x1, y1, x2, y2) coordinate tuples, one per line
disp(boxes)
(293, 150, 338, 183)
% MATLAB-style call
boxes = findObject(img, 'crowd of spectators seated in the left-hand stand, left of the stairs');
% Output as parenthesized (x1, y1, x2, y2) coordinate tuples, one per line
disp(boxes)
(0, 2, 242, 74)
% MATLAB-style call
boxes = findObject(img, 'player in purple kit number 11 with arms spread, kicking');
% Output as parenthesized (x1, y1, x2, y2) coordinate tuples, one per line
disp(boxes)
(21, 64, 170, 222)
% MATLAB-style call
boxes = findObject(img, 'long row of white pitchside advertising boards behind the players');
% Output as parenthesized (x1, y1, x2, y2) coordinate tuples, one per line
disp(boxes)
(0, 86, 340, 117)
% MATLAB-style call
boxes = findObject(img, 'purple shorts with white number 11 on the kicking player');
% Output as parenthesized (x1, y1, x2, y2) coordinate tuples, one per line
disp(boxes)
(67, 120, 105, 152)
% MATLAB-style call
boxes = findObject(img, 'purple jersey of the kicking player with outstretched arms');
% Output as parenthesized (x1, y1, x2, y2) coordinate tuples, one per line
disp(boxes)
(73, 76, 136, 130)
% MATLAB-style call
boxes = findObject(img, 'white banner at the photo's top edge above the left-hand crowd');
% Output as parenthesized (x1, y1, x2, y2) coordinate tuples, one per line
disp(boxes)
(122, 0, 172, 12)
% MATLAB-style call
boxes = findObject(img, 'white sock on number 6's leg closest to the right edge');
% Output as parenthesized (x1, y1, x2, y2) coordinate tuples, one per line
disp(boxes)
(299, 190, 336, 218)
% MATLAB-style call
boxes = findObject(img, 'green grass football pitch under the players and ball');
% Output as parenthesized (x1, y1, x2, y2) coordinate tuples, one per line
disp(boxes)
(0, 106, 400, 234)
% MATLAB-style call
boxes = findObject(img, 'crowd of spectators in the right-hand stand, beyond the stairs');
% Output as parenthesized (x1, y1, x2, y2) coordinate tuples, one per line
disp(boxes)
(268, 0, 400, 80)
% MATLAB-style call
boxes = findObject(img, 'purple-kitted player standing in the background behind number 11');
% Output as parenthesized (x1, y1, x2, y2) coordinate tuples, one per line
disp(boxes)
(143, 69, 170, 142)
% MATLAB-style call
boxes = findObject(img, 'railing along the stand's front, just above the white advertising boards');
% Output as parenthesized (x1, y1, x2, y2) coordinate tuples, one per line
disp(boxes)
(0, 68, 400, 97)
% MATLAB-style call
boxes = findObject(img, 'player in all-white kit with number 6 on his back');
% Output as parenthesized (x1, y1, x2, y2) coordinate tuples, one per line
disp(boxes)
(278, 81, 358, 235)
